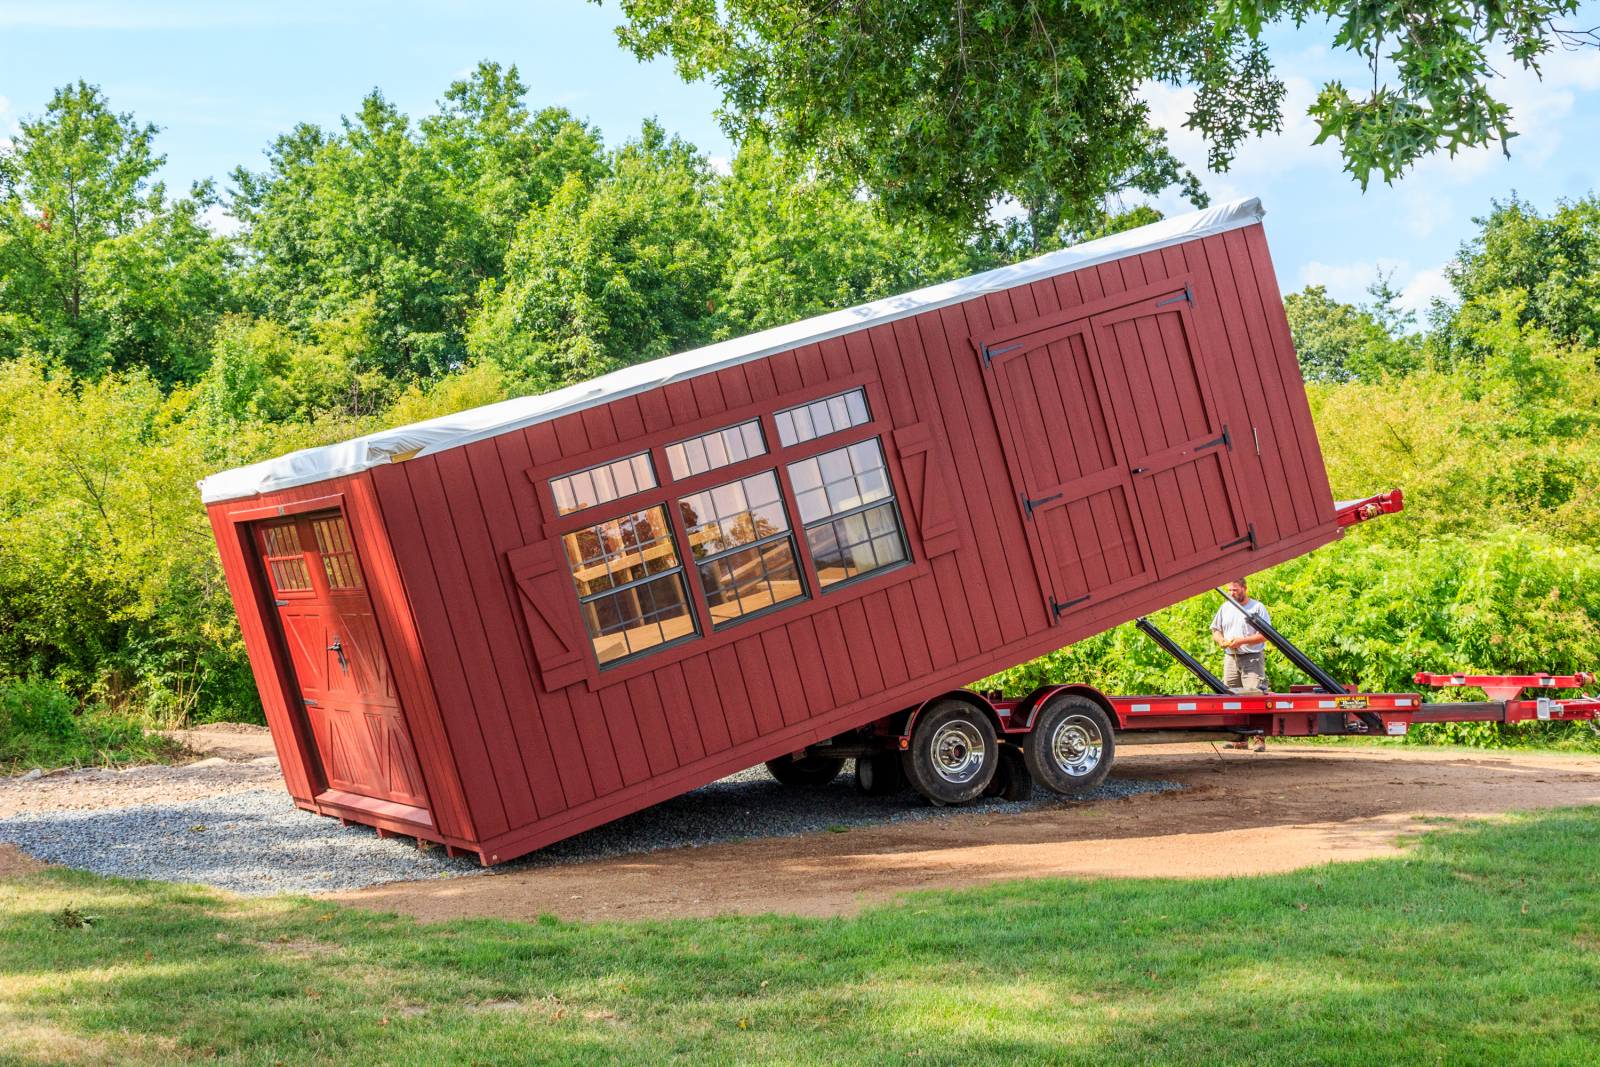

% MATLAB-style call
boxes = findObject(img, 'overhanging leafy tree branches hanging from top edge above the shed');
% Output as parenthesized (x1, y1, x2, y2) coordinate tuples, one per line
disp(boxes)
(604, 0, 1578, 227)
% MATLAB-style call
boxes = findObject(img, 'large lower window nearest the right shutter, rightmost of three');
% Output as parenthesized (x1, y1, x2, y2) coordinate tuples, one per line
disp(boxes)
(789, 438, 909, 589)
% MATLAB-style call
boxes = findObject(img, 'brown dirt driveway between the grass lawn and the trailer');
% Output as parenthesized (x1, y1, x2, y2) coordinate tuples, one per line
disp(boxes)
(331, 744, 1600, 920)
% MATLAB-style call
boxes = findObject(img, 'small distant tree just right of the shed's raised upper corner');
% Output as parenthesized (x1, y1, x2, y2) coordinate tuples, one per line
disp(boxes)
(1283, 278, 1422, 382)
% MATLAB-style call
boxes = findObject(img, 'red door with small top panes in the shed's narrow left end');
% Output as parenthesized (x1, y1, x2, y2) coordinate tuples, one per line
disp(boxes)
(254, 510, 427, 808)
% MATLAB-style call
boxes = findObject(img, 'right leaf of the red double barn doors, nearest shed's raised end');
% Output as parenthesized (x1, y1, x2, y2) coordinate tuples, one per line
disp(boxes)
(1091, 286, 1251, 577)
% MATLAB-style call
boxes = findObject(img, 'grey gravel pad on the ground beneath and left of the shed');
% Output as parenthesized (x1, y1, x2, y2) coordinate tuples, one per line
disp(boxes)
(0, 768, 1179, 896)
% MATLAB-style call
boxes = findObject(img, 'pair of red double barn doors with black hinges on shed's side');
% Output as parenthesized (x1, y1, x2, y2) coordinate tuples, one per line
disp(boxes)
(982, 293, 1250, 616)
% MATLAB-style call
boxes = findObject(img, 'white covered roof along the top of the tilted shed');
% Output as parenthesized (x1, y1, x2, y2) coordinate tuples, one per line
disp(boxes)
(200, 197, 1262, 504)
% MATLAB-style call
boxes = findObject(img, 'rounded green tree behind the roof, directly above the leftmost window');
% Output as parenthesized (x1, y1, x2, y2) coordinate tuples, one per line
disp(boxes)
(472, 122, 726, 389)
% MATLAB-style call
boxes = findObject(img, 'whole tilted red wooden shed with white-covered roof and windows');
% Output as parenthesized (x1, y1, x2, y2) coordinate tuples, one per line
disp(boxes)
(202, 200, 1338, 862)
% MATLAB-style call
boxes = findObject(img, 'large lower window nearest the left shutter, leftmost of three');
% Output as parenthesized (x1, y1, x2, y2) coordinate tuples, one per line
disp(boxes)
(562, 506, 694, 667)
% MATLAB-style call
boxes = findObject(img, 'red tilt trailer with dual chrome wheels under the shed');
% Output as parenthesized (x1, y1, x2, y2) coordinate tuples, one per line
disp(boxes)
(787, 490, 1600, 803)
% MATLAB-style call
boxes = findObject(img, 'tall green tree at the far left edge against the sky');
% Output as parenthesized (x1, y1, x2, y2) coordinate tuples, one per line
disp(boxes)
(0, 82, 229, 386)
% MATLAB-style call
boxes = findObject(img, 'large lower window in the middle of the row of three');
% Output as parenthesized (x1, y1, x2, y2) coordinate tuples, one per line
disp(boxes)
(678, 470, 805, 627)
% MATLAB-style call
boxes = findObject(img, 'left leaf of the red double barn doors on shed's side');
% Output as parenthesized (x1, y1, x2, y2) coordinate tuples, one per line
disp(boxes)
(986, 320, 1154, 617)
